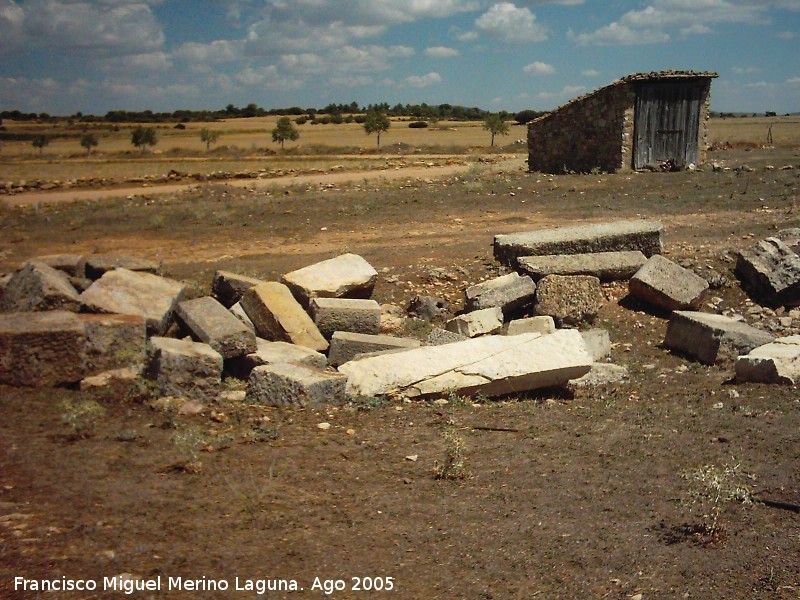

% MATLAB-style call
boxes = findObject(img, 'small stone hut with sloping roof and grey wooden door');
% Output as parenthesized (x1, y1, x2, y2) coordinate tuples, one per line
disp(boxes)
(528, 71, 718, 173)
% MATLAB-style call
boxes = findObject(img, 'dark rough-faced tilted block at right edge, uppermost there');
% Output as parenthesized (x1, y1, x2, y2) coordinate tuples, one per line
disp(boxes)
(736, 238, 800, 306)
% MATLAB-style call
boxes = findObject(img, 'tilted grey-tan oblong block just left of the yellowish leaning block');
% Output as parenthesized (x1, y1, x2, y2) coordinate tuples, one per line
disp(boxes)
(175, 296, 256, 358)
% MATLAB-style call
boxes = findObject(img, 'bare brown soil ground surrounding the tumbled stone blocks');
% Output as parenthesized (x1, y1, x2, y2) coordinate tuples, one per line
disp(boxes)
(0, 148, 800, 599)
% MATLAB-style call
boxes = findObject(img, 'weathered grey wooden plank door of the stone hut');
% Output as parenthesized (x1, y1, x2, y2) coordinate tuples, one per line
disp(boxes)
(633, 81, 703, 169)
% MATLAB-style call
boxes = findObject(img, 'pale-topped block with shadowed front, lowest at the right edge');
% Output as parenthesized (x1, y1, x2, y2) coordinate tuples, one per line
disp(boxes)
(736, 335, 800, 385)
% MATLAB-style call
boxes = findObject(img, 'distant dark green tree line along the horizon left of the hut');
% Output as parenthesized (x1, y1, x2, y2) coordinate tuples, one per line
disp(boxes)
(0, 102, 546, 125)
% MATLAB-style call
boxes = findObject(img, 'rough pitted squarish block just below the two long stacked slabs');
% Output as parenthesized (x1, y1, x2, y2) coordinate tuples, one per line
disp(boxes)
(534, 275, 605, 326)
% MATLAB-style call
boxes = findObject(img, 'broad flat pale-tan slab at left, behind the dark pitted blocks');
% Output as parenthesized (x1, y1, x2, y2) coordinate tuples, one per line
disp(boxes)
(81, 269, 186, 335)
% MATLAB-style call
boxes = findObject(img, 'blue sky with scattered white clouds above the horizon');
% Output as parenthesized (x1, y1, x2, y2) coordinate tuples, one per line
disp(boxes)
(0, 0, 800, 115)
